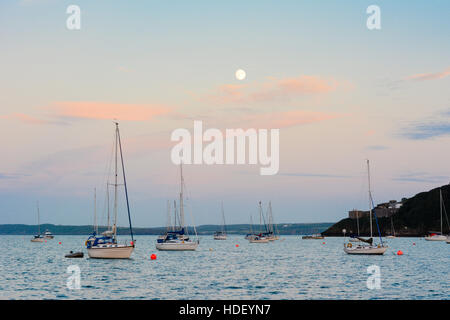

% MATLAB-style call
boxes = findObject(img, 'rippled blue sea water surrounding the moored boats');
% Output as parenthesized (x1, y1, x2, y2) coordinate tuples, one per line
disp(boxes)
(0, 236, 450, 299)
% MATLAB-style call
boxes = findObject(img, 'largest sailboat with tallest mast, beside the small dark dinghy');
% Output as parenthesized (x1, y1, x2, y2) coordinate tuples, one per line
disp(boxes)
(86, 122, 135, 259)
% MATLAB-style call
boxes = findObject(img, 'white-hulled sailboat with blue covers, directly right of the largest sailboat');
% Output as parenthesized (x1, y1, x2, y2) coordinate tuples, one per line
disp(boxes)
(156, 164, 199, 251)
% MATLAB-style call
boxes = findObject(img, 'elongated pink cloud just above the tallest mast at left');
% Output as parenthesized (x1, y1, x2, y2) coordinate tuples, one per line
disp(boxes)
(48, 101, 171, 121)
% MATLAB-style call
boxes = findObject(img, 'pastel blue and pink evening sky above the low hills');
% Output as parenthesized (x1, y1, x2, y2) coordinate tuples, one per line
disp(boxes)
(0, 0, 450, 227)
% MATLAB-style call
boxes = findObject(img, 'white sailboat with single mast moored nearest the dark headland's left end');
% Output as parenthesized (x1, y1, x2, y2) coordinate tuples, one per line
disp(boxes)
(344, 160, 387, 255)
